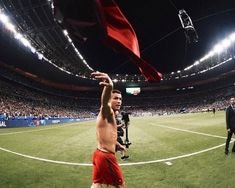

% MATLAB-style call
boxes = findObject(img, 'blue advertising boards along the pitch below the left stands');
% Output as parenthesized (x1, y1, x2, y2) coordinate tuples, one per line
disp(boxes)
(0, 118, 94, 128)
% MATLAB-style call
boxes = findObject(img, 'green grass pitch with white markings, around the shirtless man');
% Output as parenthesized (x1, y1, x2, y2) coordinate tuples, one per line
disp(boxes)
(0, 112, 235, 188)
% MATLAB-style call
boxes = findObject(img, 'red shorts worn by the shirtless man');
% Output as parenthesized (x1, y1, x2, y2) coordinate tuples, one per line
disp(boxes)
(92, 149, 124, 186)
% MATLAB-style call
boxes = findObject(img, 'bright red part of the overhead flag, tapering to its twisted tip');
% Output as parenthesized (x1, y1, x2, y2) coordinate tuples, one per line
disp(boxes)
(96, 0, 162, 82)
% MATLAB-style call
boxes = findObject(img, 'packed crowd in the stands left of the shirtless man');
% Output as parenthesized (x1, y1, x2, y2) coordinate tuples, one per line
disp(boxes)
(0, 80, 98, 119)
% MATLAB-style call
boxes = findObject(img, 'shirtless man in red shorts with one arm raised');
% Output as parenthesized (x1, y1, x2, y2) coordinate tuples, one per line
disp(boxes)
(91, 72, 126, 188)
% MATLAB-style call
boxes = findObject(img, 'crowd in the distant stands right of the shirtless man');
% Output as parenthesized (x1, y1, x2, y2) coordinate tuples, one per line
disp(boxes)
(124, 86, 231, 116)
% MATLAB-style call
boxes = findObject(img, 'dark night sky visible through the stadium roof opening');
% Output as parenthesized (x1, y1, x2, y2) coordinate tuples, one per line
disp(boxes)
(76, 0, 235, 74)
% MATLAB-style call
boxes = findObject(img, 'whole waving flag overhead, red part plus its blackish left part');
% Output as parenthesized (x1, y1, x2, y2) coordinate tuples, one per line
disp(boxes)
(54, 0, 162, 82)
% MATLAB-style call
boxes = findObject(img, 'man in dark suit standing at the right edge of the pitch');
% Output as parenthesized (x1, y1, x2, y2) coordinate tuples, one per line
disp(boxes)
(225, 97, 235, 155)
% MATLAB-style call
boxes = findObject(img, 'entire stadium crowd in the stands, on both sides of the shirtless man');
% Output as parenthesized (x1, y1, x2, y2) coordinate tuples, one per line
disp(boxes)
(0, 75, 235, 122)
